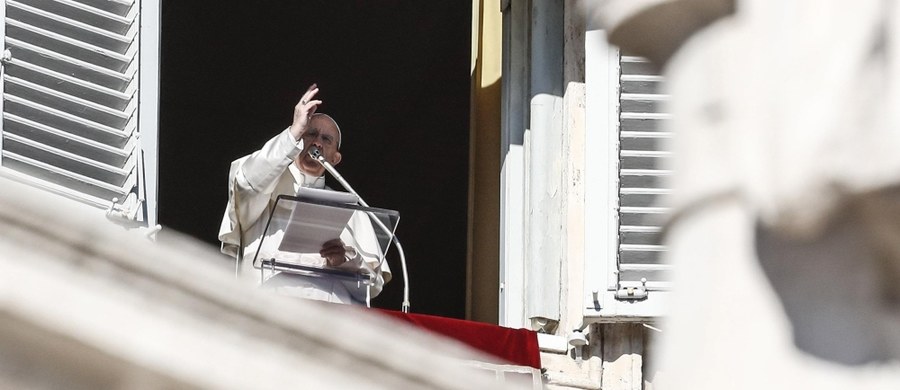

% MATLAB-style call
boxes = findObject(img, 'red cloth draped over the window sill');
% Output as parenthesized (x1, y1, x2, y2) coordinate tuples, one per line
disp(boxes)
(378, 309, 541, 369)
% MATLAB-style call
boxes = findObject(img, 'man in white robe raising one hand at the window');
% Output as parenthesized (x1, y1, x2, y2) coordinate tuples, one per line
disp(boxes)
(219, 85, 391, 304)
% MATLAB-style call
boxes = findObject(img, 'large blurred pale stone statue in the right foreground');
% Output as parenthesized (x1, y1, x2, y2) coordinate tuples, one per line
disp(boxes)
(588, 0, 900, 389)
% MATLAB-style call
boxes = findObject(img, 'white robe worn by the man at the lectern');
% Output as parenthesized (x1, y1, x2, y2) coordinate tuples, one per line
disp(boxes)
(219, 130, 391, 304)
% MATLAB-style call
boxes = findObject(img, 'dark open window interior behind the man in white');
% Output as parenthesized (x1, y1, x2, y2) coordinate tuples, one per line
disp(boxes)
(159, 0, 471, 318)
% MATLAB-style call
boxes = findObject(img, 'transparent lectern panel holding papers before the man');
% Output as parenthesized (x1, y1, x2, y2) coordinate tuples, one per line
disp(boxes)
(253, 191, 400, 279)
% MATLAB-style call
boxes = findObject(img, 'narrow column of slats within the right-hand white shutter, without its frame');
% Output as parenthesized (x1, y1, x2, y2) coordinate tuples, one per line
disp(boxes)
(616, 55, 671, 299)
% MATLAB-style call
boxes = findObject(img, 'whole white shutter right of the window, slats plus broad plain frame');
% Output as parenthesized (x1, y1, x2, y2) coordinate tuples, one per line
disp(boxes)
(583, 30, 671, 321)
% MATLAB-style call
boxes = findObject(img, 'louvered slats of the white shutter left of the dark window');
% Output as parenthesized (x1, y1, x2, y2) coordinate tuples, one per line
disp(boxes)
(0, 0, 156, 221)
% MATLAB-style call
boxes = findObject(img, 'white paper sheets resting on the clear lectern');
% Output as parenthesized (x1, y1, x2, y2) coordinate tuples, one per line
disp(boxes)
(278, 188, 357, 253)
